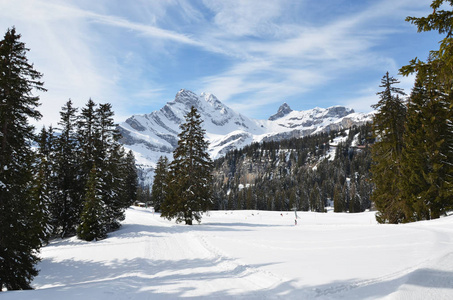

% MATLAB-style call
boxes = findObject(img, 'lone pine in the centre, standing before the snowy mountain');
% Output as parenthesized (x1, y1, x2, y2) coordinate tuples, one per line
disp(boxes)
(161, 107, 213, 225)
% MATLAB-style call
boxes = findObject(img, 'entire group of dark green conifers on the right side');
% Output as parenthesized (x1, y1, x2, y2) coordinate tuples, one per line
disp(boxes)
(372, 0, 453, 223)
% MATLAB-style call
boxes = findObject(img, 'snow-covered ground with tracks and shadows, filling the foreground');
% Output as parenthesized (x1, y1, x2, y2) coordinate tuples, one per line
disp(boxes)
(0, 208, 453, 300)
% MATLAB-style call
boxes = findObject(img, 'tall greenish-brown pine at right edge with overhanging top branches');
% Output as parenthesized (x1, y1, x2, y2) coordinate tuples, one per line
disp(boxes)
(400, 0, 453, 220)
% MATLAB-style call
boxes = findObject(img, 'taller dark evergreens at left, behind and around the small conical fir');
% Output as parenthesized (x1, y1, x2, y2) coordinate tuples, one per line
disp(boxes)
(42, 99, 138, 237)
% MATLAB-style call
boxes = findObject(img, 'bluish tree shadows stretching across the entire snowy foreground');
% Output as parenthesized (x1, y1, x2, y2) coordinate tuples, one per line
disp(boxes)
(9, 253, 453, 300)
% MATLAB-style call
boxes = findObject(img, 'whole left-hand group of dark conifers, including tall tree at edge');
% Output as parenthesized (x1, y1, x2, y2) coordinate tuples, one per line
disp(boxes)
(0, 28, 137, 291)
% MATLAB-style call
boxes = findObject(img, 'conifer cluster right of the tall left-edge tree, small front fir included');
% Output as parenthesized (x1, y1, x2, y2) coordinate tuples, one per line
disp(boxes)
(37, 99, 138, 241)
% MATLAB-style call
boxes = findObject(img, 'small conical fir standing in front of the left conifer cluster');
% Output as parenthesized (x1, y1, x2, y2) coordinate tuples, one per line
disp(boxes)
(77, 165, 107, 241)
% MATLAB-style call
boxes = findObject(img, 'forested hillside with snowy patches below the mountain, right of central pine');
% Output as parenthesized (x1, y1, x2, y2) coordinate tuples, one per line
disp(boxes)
(214, 124, 374, 212)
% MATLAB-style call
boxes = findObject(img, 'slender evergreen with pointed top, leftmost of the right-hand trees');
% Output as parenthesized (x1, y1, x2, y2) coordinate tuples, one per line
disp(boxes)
(371, 72, 406, 223)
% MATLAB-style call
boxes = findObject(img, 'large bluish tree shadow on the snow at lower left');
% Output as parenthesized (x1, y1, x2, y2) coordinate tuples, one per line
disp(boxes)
(30, 258, 291, 300)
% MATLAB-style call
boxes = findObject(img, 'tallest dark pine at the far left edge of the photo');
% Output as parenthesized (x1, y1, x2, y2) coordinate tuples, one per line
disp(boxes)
(0, 28, 45, 291)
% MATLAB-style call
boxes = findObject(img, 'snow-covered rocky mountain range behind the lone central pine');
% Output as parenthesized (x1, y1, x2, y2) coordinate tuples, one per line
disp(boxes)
(119, 90, 371, 183)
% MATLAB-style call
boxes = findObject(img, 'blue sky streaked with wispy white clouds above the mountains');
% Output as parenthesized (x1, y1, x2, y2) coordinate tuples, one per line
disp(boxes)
(0, 0, 442, 126)
